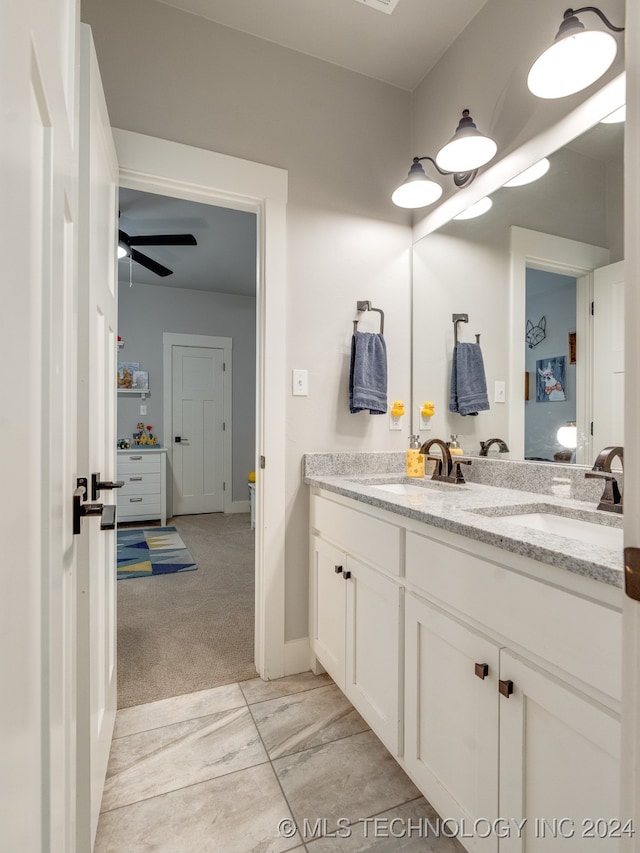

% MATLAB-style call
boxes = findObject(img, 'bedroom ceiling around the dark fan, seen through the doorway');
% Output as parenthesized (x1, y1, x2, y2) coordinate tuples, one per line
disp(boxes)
(118, 188, 257, 296)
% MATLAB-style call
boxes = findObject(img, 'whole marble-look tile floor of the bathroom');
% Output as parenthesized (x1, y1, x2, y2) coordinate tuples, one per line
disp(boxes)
(95, 672, 463, 853)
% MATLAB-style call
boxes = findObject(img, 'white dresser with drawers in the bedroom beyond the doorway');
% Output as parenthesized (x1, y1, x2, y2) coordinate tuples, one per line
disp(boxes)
(118, 447, 167, 527)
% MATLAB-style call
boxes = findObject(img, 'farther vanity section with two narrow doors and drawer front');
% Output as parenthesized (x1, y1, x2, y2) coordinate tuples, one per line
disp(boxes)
(309, 496, 403, 755)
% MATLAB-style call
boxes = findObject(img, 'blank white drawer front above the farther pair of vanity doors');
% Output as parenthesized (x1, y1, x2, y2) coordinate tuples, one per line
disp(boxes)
(312, 495, 402, 575)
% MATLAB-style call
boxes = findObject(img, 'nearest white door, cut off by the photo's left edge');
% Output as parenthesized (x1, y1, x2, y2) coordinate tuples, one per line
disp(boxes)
(0, 0, 79, 853)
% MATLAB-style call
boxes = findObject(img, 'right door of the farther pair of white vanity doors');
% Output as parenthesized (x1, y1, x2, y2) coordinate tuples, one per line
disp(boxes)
(345, 557, 403, 755)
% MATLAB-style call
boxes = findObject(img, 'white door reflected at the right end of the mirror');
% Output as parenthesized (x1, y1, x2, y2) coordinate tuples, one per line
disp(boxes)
(592, 261, 624, 456)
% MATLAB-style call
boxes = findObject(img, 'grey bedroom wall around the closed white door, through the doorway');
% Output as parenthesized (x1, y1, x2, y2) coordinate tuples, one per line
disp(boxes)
(118, 284, 256, 501)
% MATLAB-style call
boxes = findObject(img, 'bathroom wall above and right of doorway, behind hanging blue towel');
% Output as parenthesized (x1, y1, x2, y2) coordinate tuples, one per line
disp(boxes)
(82, 0, 411, 639)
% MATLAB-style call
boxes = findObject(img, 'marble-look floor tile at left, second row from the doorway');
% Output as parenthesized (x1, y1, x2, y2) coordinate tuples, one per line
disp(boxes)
(102, 706, 267, 811)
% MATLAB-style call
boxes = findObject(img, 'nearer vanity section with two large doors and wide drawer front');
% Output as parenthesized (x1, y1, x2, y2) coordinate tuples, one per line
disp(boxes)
(405, 530, 622, 853)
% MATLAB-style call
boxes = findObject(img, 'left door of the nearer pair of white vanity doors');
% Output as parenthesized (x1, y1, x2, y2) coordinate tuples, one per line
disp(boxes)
(405, 594, 499, 851)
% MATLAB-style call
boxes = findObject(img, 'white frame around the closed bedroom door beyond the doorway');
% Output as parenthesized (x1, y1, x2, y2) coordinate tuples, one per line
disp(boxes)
(162, 332, 233, 515)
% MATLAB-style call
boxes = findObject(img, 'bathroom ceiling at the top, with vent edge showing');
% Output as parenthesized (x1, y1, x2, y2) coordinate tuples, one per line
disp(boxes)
(151, 0, 487, 91)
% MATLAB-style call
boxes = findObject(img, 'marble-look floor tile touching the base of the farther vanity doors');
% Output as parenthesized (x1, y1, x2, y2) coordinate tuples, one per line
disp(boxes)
(251, 684, 369, 758)
